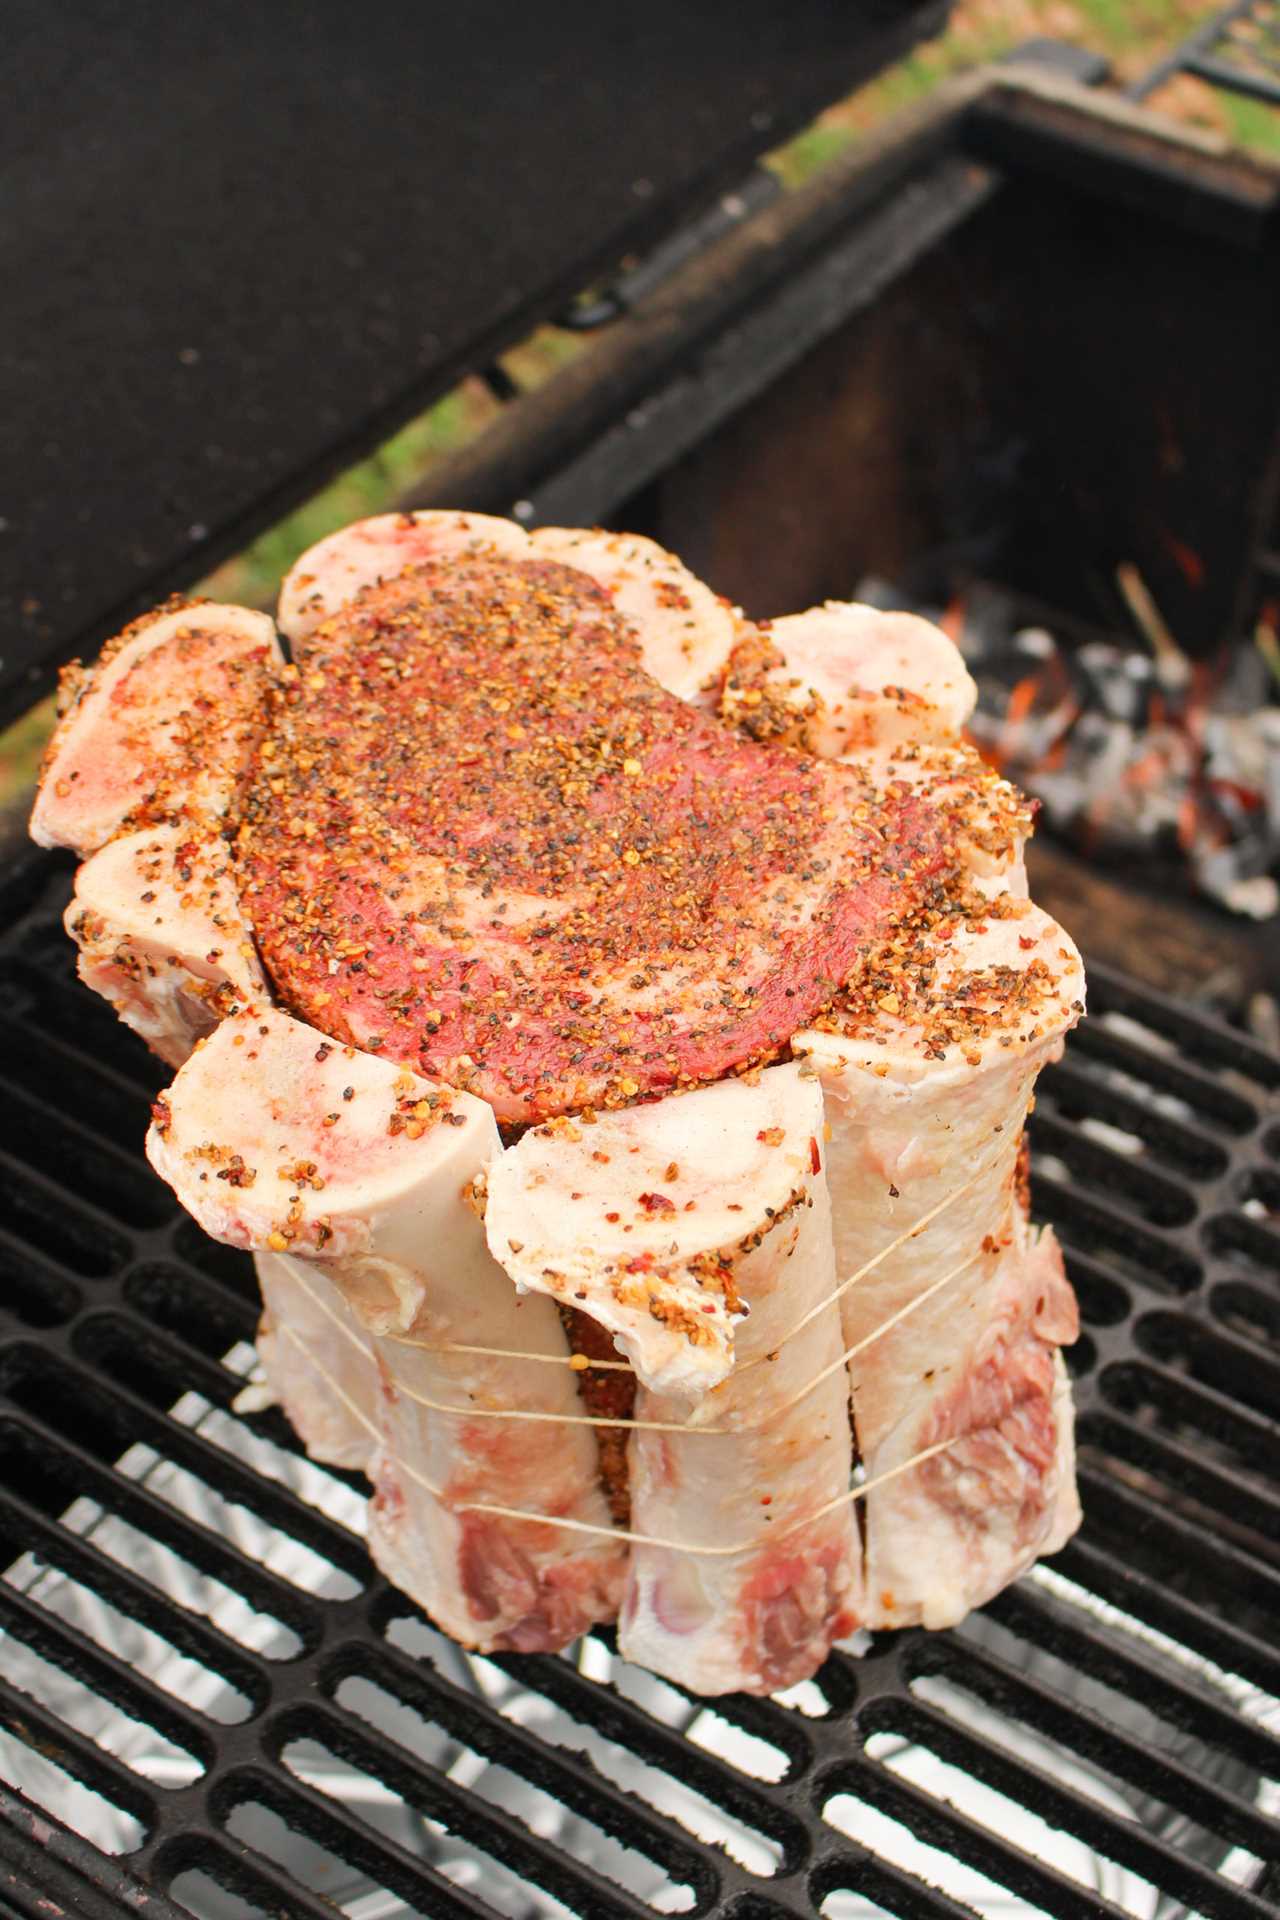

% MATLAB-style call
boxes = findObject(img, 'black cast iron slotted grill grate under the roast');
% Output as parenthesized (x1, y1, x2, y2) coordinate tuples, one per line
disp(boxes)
(0, 858, 1280, 1920)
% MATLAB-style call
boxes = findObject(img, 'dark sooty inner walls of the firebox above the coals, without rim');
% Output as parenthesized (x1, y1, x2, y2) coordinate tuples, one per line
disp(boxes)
(620, 133, 1280, 655)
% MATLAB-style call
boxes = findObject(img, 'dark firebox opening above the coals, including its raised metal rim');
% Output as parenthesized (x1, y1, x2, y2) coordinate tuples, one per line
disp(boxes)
(475, 79, 1280, 657)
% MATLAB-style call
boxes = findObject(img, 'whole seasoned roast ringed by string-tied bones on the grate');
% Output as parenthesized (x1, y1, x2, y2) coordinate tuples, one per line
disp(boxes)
(33, 513, 1084, 1693)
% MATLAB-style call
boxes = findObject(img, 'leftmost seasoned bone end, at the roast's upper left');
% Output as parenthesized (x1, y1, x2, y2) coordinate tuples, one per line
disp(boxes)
(31, 601, 280, 854)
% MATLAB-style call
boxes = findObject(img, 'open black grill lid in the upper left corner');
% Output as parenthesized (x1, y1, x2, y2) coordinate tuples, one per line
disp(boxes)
(0, 0, 946, 720)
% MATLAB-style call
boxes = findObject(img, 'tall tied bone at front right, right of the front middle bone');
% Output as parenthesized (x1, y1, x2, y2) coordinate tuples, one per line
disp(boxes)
(794, 895, 1082, 1626)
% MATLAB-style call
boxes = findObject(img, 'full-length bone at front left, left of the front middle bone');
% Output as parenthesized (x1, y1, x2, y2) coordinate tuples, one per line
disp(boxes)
(148, 1008, 622, 1649)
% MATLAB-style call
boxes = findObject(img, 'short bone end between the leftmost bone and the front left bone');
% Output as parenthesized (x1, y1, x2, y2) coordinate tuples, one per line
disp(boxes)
(65, 822, 267, 1068)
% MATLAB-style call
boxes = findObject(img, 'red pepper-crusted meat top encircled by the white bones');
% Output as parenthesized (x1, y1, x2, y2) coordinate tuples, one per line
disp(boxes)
(240, 557, 946, 1121)
